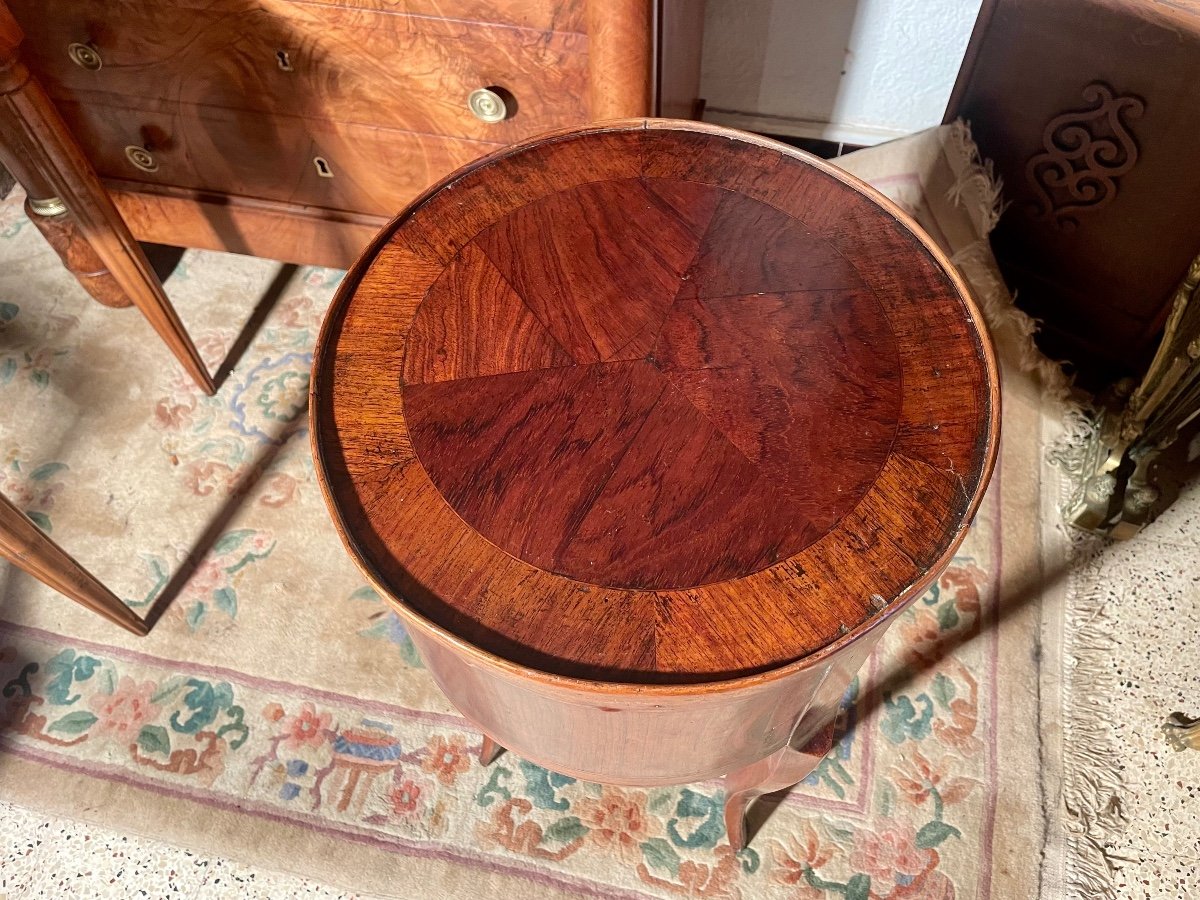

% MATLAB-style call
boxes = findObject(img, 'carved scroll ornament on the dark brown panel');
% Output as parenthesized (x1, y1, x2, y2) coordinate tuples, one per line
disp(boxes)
(1025, 82, 1146, 232)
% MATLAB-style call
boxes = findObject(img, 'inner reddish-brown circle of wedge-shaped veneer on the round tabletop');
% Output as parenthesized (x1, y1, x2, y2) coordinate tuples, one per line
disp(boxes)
(403, 178, 900, 590)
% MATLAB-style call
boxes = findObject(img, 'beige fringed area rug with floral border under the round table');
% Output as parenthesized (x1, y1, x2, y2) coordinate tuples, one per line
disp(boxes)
(0, 130, 1040, 900)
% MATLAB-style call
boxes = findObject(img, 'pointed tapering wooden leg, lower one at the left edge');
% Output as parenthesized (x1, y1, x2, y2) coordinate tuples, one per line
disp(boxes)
(0, 494, 150, 635)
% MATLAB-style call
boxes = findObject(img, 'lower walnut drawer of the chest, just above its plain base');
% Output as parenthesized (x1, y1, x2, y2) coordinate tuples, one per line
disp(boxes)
(59, 102, 500, 217)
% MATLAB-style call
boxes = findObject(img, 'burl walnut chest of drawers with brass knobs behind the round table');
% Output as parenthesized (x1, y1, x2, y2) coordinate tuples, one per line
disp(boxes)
(0, 0, 703, 386)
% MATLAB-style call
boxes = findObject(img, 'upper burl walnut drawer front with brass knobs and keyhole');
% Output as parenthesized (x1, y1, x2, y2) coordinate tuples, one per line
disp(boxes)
(11, 0, 588, 143)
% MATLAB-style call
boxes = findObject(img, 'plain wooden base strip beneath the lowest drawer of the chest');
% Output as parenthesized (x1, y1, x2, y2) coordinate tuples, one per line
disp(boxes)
(106, 182, 386, 269)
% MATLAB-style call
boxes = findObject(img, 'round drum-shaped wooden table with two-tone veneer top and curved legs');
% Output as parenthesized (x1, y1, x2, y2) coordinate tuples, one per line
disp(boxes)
(311, 120, 998, 847)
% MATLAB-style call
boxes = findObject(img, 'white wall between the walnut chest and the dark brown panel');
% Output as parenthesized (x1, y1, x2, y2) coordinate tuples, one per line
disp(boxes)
(700, 0, 982, 144)
